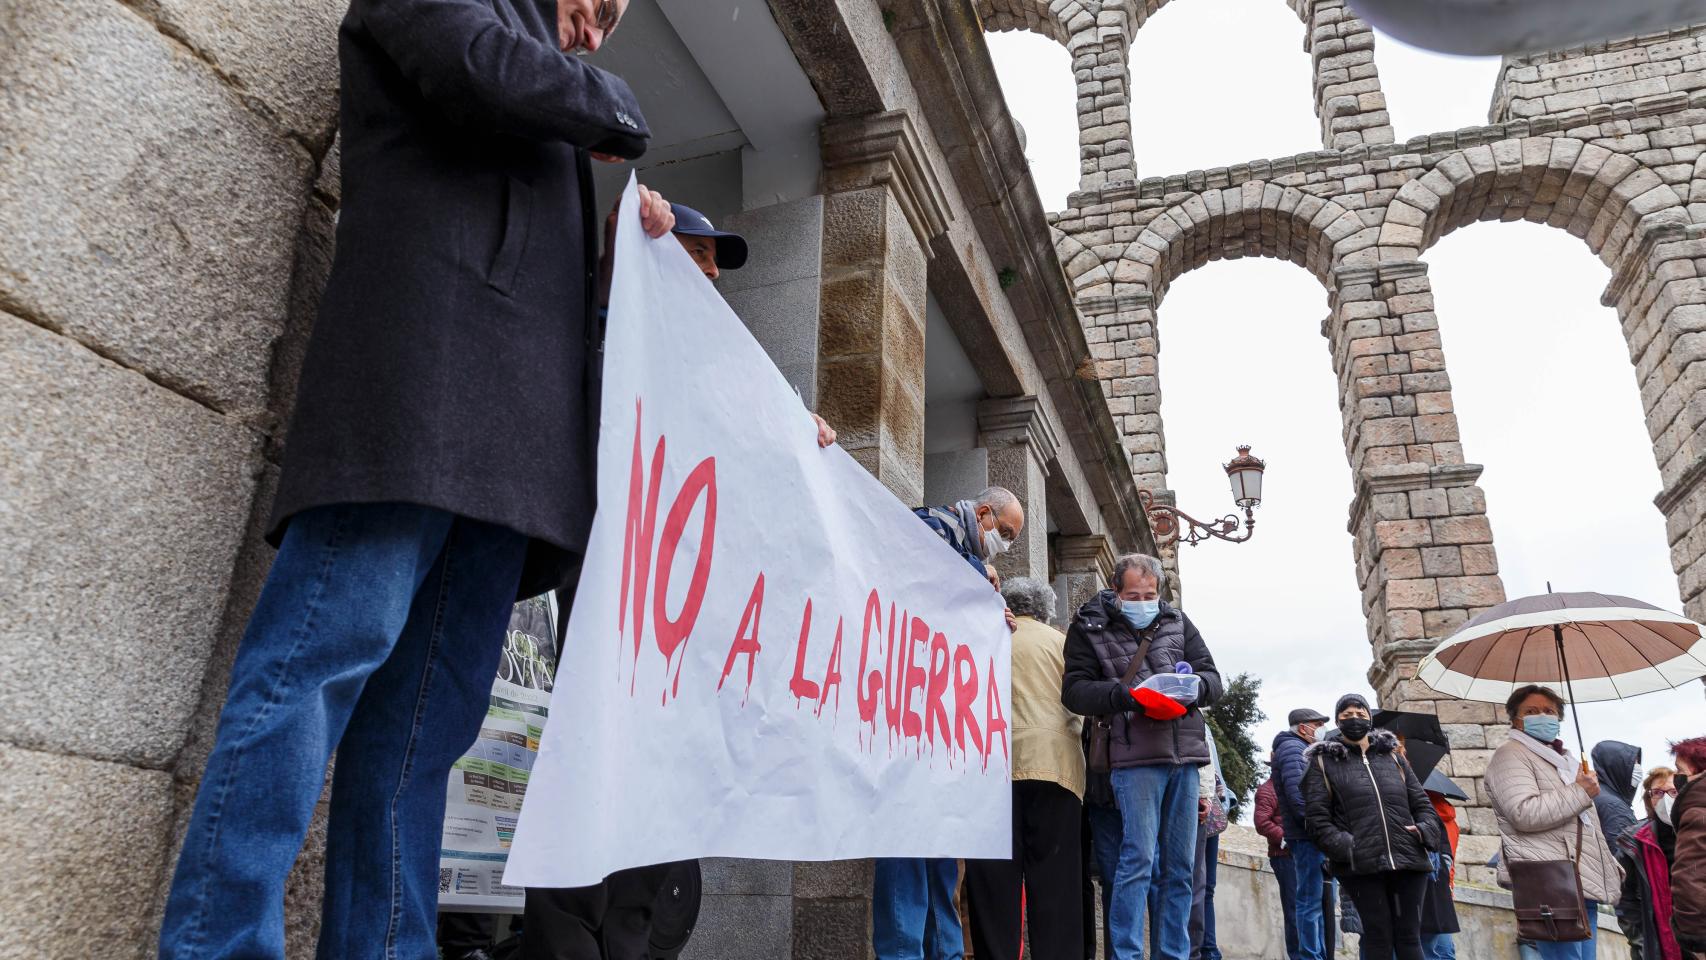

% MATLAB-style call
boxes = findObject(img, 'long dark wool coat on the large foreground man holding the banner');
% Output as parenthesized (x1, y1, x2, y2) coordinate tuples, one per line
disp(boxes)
(270, 0, 650, 595)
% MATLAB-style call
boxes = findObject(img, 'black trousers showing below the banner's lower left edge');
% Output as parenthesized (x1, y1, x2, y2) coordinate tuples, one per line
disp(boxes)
(522, 863, 670, 960)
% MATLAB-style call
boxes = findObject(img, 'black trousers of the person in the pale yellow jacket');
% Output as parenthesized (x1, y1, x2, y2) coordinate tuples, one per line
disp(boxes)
(966, 779, 1083, 960)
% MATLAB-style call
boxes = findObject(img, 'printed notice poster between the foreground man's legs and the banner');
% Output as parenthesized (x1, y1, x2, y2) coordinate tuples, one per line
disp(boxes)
(438, 593, 558, 914)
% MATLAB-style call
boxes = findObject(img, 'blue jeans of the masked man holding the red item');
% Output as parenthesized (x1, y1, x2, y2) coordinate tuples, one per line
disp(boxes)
(1109, 764, 1198, 960)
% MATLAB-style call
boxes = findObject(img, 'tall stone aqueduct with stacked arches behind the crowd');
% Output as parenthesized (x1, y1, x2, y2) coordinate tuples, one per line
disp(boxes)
(979, 0, 1706, 880)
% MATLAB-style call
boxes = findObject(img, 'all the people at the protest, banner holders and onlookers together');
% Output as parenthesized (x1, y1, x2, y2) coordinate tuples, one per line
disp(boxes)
(150, 0, 1706, 960)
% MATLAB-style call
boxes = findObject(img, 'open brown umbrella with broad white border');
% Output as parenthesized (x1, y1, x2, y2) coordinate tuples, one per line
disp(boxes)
(1416, 593, 1706, 762)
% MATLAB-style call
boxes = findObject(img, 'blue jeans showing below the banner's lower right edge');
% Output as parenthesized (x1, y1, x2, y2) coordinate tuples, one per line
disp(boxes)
(870, 858, 966, 960)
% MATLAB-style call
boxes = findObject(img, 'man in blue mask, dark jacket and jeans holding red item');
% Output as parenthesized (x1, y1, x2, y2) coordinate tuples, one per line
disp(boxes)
(1061, 554, 1221, 960)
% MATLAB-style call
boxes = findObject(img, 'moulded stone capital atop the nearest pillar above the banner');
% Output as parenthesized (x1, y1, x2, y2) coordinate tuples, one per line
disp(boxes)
(821, 111, 954, 257)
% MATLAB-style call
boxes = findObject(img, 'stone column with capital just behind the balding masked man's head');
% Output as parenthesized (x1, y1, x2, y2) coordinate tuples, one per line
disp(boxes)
(978, 397, 1059, 580)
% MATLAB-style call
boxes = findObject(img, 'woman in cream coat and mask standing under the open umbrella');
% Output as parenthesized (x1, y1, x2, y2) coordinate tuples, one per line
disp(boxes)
(1486, 685, 1622, 960)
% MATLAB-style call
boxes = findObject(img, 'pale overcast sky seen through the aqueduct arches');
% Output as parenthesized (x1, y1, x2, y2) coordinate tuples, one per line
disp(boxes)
(989, 0, 1706, 798)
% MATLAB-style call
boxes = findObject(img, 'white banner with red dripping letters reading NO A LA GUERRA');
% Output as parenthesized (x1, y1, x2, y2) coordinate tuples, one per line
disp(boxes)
(505, 181, 1012, 887)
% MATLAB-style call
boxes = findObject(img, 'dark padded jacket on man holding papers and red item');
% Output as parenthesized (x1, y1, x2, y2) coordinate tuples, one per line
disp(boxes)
(1061, 590, 1221, 769)
